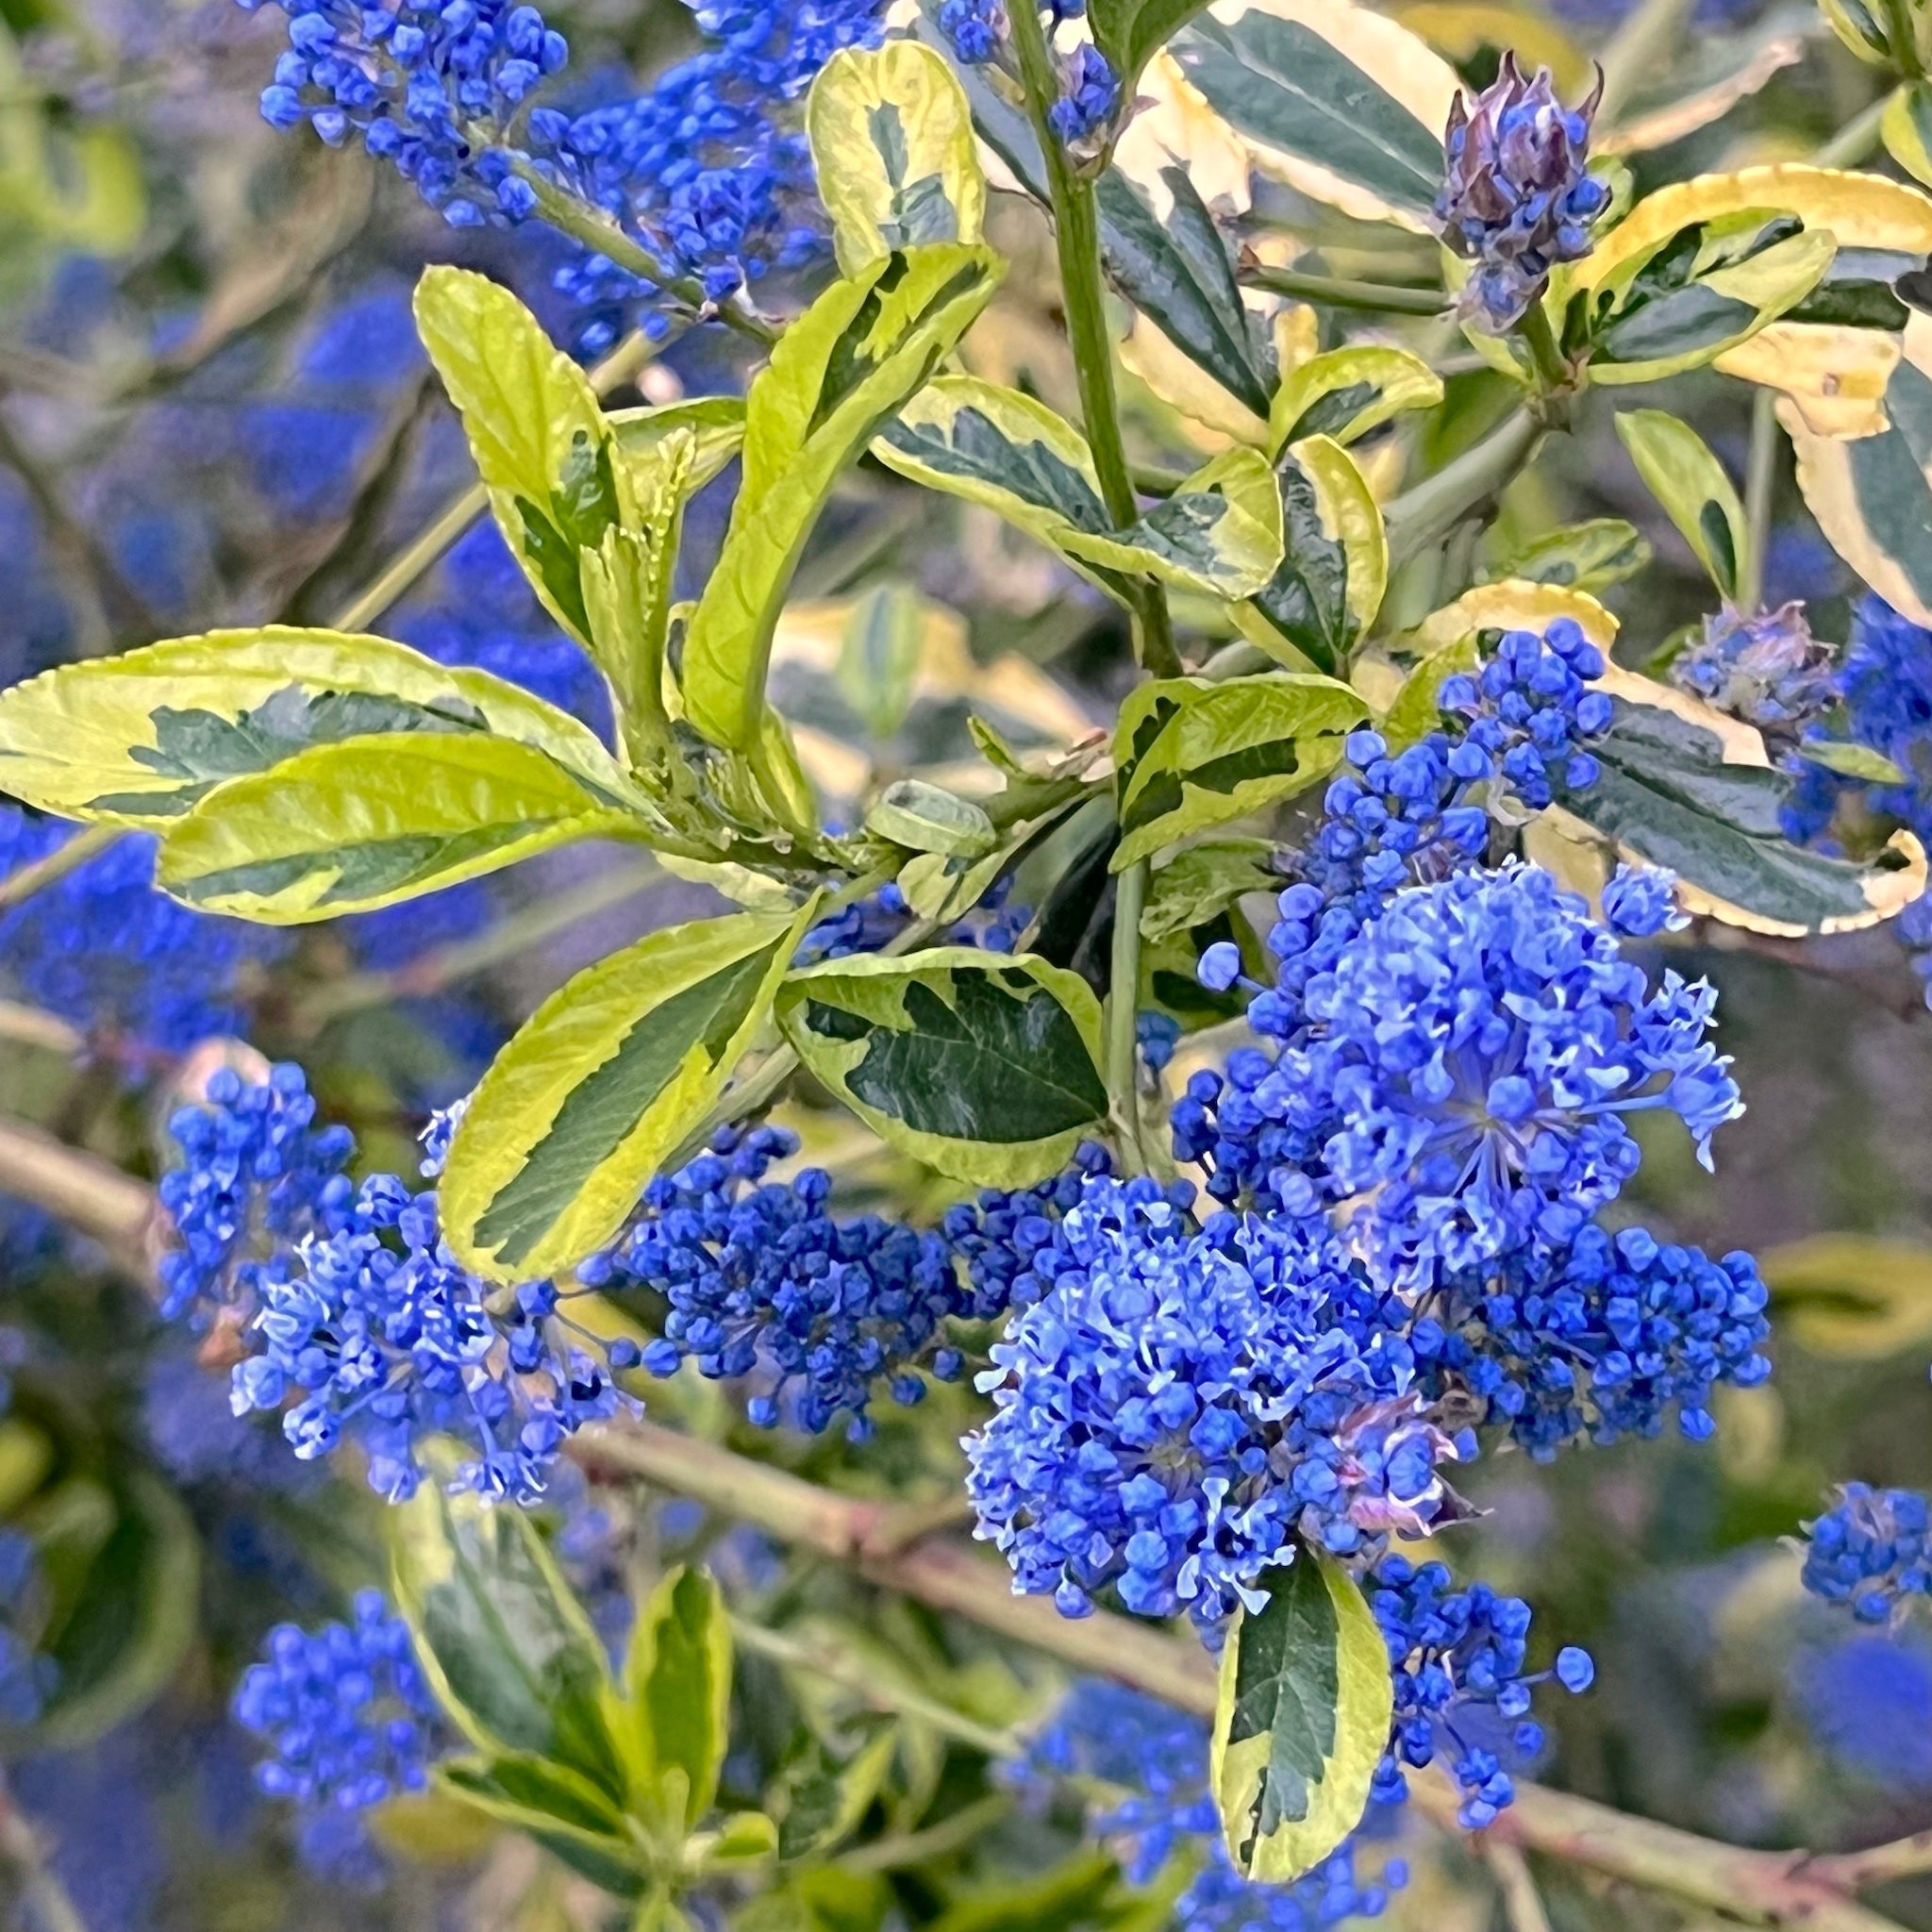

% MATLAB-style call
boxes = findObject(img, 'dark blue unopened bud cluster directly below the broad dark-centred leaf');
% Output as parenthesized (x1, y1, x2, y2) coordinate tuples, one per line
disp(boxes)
(583, 1126, 981, 1441)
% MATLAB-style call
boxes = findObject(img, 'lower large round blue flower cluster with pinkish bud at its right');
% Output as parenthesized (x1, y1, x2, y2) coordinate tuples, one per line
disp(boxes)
(966, 1178, 1474, 1626)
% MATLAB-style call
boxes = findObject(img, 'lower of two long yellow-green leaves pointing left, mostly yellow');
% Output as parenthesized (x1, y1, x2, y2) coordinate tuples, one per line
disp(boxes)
(155, 732, 636, 925)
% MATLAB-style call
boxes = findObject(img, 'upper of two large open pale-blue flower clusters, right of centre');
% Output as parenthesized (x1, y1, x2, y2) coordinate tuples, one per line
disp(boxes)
(1174, 863, 1742, 1287)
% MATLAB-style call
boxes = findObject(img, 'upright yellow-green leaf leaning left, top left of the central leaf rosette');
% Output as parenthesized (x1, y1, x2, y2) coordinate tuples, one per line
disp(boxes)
(415, 267, 636, 645)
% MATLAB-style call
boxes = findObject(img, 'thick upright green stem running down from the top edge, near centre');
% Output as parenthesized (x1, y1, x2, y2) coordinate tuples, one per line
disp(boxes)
(1008, 6, 1182, 678)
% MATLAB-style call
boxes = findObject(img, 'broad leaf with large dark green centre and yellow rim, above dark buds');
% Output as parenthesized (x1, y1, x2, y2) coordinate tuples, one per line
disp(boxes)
(778, 947, 1108, 1189)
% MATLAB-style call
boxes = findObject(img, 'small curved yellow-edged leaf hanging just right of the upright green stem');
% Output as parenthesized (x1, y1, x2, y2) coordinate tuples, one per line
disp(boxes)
(1233, 437, 1390, 671)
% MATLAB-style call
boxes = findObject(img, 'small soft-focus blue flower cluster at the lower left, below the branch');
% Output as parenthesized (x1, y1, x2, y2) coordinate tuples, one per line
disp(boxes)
(234, 1591, 448, 1838)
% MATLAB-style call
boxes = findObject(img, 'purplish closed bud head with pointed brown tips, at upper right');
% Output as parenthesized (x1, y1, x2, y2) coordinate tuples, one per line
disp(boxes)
(1436, 54, 1609, 334)
